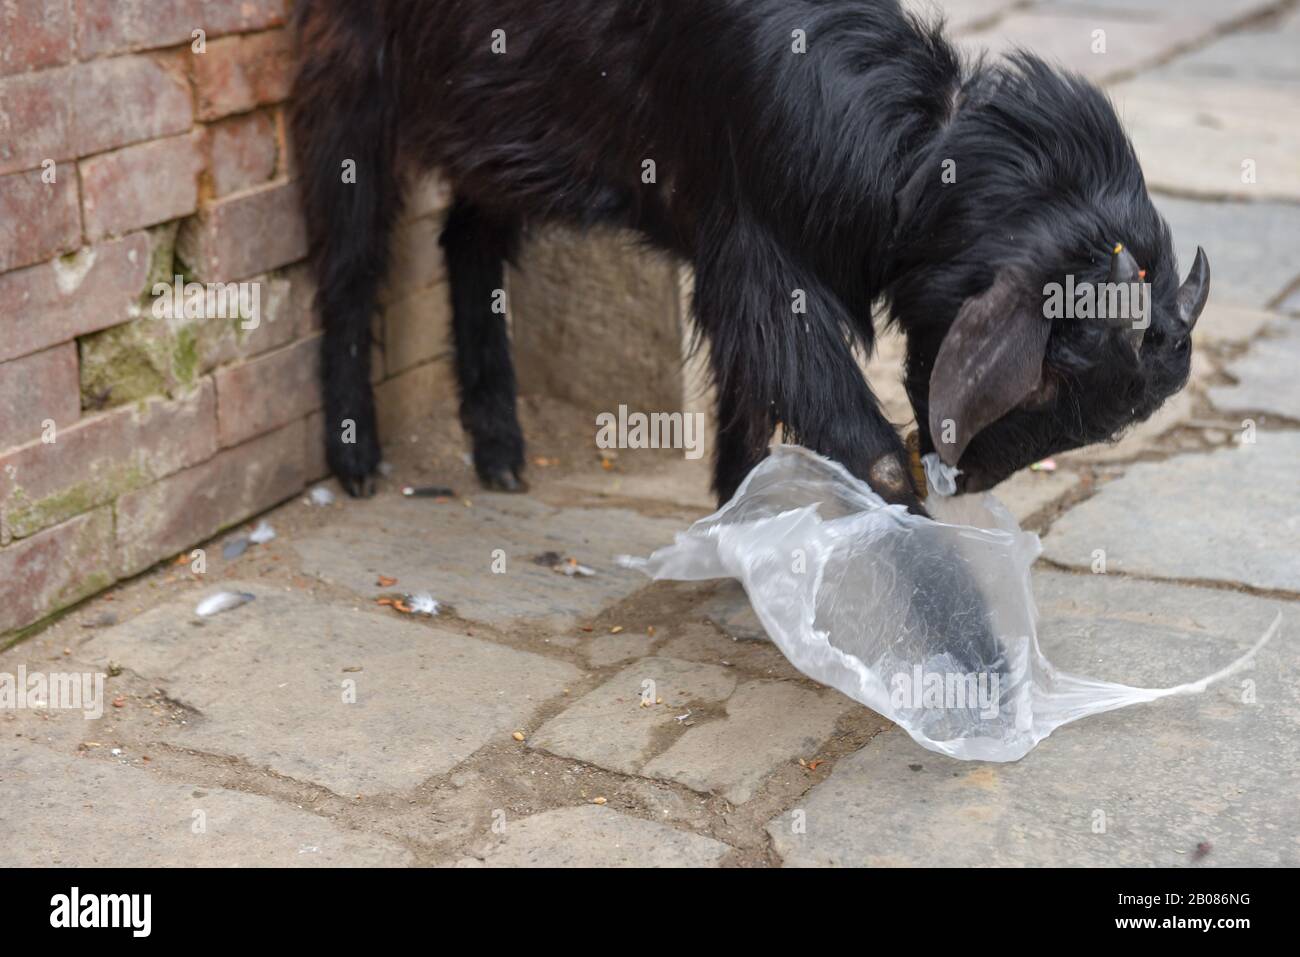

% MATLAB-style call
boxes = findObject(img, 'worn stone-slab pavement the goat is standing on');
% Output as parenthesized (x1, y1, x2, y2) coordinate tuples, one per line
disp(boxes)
(0, 0, 1300, 866)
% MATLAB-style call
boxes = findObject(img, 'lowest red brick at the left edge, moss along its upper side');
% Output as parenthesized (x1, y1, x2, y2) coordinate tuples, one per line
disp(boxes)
(0, 507, 114, 633)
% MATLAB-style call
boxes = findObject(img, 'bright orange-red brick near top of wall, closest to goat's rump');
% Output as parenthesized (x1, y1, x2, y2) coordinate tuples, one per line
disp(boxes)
(191, 30, 294, 120)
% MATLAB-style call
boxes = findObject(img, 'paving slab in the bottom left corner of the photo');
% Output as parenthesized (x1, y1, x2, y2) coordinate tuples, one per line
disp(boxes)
(0, 740, 411, 867)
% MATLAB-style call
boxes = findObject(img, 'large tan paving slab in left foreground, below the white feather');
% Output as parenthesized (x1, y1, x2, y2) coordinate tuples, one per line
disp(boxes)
(86, 583, 579, 797)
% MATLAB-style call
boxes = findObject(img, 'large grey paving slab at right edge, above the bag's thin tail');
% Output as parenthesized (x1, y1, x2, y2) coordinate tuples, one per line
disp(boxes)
(1043, 432, 1300, 592)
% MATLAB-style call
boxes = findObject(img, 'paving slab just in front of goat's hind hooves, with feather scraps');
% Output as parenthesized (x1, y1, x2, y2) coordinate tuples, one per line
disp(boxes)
(293, 493, 681, 629)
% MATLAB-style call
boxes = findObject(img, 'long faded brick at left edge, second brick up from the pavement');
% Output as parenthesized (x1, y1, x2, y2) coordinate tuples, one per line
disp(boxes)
(0, 380, 216, 538)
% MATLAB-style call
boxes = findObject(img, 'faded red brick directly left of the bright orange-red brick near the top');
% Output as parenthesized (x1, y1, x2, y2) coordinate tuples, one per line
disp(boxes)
(72, 56, 194, 156)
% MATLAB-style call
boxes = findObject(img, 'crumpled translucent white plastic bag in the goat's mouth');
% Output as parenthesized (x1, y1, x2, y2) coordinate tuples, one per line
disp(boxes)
(623, 445, 1281, 761)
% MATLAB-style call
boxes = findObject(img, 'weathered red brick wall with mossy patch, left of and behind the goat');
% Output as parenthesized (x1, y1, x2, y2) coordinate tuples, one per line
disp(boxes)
(0, 0, 451, 636)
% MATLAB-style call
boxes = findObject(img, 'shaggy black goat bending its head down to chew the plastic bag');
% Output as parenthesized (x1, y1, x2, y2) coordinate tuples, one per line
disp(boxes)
(293, 0, 1190, 510)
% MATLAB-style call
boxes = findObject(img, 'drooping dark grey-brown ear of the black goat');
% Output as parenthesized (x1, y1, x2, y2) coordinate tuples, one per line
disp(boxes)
(930, 272, 1052, 465)
